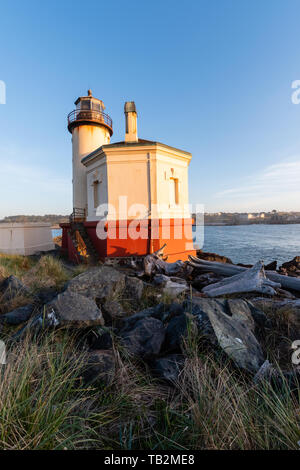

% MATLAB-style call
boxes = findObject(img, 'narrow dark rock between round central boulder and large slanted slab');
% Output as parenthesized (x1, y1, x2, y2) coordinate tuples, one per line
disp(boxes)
(164, 313, 196, 352)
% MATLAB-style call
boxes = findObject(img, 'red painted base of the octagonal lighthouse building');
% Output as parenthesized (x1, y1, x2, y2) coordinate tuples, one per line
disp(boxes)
(60, 219, 196, 262)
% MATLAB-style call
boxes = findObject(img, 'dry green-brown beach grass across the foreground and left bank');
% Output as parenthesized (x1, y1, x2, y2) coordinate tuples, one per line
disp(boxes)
(0, 252, 300, 450)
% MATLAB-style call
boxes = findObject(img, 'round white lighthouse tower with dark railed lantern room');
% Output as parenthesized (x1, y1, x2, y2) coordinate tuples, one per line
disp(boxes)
(68, 90, 113, 214)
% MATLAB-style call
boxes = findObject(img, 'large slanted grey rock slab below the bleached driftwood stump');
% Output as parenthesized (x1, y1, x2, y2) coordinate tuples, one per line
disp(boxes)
(190, 299, 264, 374)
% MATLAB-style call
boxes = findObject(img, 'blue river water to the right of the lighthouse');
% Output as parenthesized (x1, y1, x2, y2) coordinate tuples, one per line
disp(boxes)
(52, 224, 300, 264)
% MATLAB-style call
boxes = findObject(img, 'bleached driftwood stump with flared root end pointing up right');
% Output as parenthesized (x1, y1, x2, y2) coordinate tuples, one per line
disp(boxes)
(202, 261, 281, 297)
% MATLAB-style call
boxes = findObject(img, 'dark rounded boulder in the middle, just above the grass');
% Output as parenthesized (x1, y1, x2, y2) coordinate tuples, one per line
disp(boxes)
(120, 317, 165, 359)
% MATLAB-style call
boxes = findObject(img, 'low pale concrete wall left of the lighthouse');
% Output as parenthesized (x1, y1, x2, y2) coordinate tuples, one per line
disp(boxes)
(0, 223, 54, 256)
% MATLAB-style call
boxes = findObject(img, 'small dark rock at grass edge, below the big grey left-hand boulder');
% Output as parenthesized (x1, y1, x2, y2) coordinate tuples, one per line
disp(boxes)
(82, 350, 116, 385)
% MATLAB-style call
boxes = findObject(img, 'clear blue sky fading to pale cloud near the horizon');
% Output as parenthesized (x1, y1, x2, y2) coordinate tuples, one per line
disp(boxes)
(0, 0, 300, 217)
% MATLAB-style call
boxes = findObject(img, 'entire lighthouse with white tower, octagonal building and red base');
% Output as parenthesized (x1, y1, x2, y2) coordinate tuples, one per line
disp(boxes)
(61, 90, 195, 262)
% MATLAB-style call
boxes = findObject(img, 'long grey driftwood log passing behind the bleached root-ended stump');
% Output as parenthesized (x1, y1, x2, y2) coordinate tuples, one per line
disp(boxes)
(189, 256, 300, 292)
